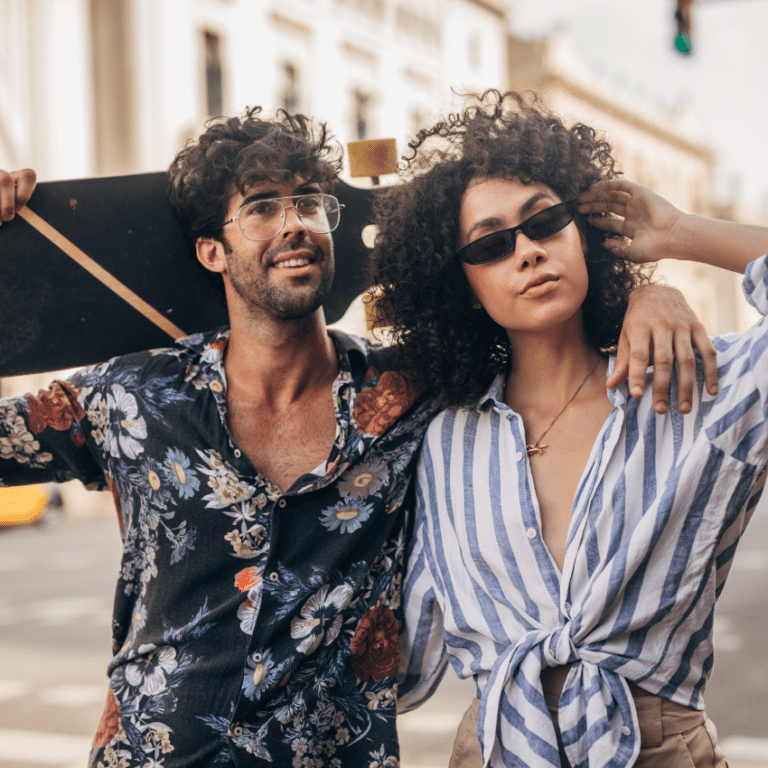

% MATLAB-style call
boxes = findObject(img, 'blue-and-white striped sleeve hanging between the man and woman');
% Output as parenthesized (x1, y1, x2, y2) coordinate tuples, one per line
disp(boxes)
(397, 480, 448, 712)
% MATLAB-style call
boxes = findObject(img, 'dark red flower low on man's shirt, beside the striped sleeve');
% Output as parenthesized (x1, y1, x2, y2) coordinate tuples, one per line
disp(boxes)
(351, 605, 400, 683)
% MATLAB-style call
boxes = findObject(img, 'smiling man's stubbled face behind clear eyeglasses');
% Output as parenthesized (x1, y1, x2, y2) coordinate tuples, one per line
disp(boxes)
(210, 179, 334, 320)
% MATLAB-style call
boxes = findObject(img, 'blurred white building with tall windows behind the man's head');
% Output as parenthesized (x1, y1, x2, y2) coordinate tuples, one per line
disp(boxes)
(0, 0, 509, 179)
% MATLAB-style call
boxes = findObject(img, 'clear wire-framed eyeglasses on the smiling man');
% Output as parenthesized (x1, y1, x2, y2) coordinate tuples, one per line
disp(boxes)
(222, 192, 344, 241)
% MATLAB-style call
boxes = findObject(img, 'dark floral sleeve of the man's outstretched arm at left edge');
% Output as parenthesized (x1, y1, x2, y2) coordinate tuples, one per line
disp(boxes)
(0, 374, 106, 488)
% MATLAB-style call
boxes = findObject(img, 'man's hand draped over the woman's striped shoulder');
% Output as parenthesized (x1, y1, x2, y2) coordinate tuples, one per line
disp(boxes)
(606, 285, 717, 413)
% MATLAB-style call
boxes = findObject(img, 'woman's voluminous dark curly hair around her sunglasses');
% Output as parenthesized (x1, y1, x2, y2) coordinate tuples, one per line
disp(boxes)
(370, 90, 648, 406)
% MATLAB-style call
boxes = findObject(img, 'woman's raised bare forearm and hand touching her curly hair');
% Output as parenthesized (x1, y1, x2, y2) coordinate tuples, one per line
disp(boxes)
(579, 179, 768, 274)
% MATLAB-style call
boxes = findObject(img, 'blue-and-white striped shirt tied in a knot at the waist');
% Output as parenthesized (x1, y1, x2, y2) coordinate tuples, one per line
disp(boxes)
(399, 256, 768, 768)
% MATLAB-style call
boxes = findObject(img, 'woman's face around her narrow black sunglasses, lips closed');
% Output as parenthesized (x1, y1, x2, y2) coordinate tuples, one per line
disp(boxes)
(459, 176, 588, 340)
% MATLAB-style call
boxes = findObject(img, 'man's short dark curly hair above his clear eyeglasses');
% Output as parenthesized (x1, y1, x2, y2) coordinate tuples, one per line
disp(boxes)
(167, 107, 342, 305)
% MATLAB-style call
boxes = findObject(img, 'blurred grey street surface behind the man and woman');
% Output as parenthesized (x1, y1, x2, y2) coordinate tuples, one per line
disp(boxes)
(0, 500, 768, 768)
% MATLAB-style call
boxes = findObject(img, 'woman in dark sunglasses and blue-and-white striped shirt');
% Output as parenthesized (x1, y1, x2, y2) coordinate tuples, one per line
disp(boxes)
(374, 92, 768, 768)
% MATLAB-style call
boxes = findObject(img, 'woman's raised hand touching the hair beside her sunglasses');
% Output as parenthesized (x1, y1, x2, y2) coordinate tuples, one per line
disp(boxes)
(578, 179, 685, 264)
